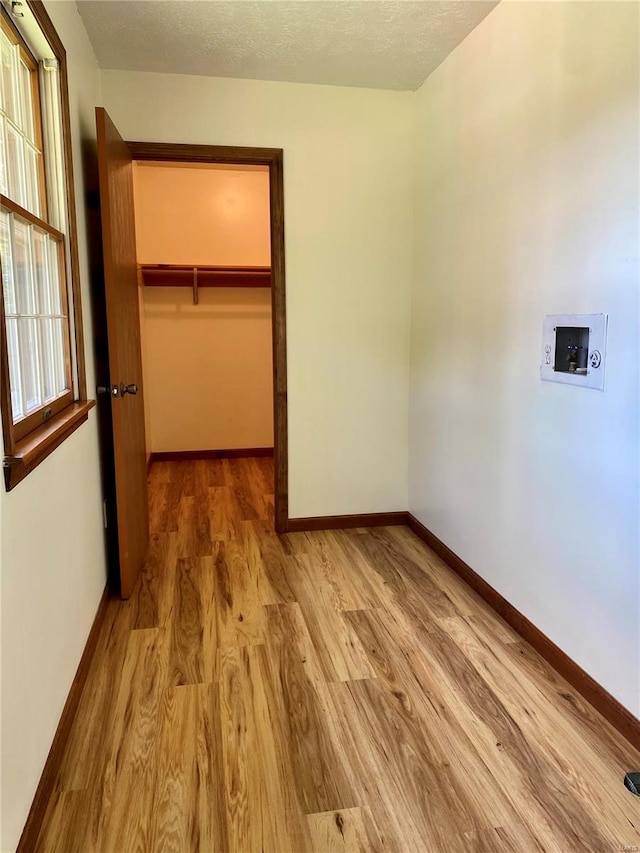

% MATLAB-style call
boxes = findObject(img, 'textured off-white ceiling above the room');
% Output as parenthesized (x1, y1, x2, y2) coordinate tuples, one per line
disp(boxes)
(77, 0, 497, 90)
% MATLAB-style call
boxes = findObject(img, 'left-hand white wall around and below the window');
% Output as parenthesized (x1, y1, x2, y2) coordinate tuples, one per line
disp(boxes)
(0, 2, 106, 853)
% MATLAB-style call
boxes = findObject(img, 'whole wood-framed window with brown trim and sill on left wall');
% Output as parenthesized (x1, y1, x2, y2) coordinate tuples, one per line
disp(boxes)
(0, 2, 92, 488)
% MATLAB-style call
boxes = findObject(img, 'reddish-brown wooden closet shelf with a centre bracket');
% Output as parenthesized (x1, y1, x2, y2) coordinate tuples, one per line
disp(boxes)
(139, 264, 271, 287)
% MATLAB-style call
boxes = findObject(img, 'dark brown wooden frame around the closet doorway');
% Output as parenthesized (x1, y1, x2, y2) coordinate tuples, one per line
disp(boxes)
(127, 142, 289, 533)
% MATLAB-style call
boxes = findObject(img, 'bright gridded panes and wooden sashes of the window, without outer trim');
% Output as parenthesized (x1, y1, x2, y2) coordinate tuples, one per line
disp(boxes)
(0, 17, 73, 429)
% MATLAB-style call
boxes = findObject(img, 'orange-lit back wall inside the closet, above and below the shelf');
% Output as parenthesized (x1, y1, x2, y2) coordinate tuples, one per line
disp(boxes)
(133, 162, 273, 451)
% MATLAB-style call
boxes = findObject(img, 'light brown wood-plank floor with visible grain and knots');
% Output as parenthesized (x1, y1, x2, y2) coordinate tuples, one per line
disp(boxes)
(38, 458, 640, 853)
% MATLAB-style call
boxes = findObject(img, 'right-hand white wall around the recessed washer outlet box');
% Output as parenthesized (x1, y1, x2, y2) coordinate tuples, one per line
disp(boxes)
(409, 2, 640, 714)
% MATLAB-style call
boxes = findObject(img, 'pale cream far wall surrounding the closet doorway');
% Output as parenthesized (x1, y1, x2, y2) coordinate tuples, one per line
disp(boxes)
(102, 71, 413, 516)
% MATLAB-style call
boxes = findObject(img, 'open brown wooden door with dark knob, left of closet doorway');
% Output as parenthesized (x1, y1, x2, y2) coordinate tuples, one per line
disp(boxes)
(96, 107, 149, 598)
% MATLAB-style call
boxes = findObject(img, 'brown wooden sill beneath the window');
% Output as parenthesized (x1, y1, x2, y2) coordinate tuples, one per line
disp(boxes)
(4, 400, 96, 492)
